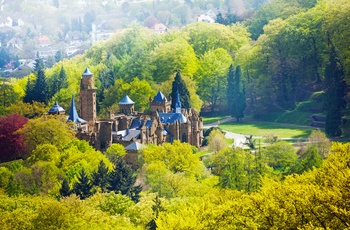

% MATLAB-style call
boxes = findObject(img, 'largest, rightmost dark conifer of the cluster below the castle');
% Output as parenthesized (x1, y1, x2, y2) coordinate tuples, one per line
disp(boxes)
(108, 157, 141, 202)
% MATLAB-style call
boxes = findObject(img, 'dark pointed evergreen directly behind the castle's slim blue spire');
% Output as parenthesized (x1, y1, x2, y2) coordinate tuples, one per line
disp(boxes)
(171, 71, 191, 109)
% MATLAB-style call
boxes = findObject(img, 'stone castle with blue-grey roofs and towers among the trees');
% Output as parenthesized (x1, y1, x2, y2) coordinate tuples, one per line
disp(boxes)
(49, 68, 203, 155)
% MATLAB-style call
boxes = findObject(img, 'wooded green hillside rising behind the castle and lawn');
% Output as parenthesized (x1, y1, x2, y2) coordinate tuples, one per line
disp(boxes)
(4, 0, 350, 136)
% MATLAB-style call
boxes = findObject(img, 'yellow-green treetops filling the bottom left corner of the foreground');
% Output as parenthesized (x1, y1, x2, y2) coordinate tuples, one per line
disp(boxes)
(0, 196, 142, 230)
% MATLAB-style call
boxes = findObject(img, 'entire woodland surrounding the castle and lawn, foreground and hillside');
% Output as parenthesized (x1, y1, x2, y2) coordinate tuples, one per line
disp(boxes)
(0, 0, 350, 229)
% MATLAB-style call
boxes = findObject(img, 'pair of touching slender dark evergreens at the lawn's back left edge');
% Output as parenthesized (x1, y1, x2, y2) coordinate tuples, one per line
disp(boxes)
(227, 65, 247, 121)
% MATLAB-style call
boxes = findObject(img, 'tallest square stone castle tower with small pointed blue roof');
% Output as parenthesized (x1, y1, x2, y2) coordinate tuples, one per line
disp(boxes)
(80, 68, 97, 121)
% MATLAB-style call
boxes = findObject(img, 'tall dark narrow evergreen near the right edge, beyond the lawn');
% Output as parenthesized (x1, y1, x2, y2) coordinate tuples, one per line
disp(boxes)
(324, 46, 346, 137)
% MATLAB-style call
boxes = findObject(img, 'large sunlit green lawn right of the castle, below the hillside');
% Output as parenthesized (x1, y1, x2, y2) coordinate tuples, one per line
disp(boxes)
(220, 122, 313, 138)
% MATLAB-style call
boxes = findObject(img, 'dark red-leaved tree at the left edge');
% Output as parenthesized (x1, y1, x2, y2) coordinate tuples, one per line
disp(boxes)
(0, 114, 28, 162)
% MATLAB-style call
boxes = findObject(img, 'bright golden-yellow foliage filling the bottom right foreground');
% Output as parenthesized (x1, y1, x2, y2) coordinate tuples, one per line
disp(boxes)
(157, 143, 350, 229)
